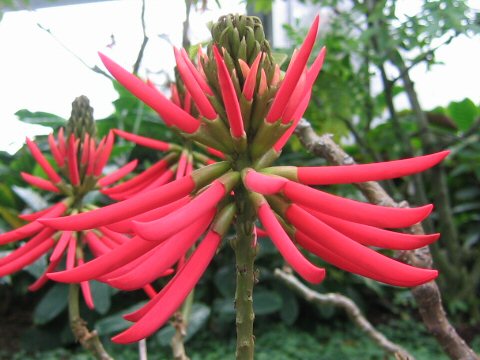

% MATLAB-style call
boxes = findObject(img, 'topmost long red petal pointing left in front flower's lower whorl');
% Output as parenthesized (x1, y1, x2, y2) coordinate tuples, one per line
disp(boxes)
(39, 176, 195, 231)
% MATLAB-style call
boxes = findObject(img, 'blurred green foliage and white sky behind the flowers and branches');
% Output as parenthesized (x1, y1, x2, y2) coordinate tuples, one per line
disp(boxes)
(0, 0, 480, 359)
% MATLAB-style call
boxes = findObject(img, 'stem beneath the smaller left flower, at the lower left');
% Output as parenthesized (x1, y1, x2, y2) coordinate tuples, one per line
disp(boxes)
(68, 284, 113, 360)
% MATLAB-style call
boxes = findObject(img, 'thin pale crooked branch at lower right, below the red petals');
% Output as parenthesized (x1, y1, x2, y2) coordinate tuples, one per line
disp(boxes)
(274, 269, 414, 360)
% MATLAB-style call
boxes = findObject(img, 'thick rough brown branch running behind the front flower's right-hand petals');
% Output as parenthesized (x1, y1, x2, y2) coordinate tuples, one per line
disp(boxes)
(296, 119, 479, 360)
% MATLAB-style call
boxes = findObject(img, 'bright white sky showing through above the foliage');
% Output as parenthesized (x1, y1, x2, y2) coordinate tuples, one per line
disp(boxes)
(0, 0, 480, 152)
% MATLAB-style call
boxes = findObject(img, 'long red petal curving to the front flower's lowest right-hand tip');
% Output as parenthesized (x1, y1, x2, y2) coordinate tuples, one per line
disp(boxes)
(286, 205, 438, 286)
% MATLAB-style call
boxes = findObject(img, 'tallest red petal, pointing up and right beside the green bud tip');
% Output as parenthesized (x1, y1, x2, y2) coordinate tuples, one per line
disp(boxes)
(266, 15, 319, 123)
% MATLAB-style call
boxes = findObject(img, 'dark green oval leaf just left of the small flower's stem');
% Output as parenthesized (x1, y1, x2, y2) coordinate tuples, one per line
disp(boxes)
(33, 284, 69, 325)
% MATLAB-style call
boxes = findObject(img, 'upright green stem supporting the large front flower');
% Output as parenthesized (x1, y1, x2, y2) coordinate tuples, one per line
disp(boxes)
(233, 186, 256, 360)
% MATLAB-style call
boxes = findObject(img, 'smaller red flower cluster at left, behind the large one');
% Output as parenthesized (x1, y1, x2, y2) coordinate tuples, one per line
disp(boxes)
(0, 97, 161, 308)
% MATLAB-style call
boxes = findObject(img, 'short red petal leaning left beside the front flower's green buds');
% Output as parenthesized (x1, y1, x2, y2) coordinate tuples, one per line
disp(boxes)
(173, 48, 217, 120)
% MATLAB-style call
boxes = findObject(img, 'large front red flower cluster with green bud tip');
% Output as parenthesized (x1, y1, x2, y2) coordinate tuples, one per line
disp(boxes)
(41, 15, 447, 344)
